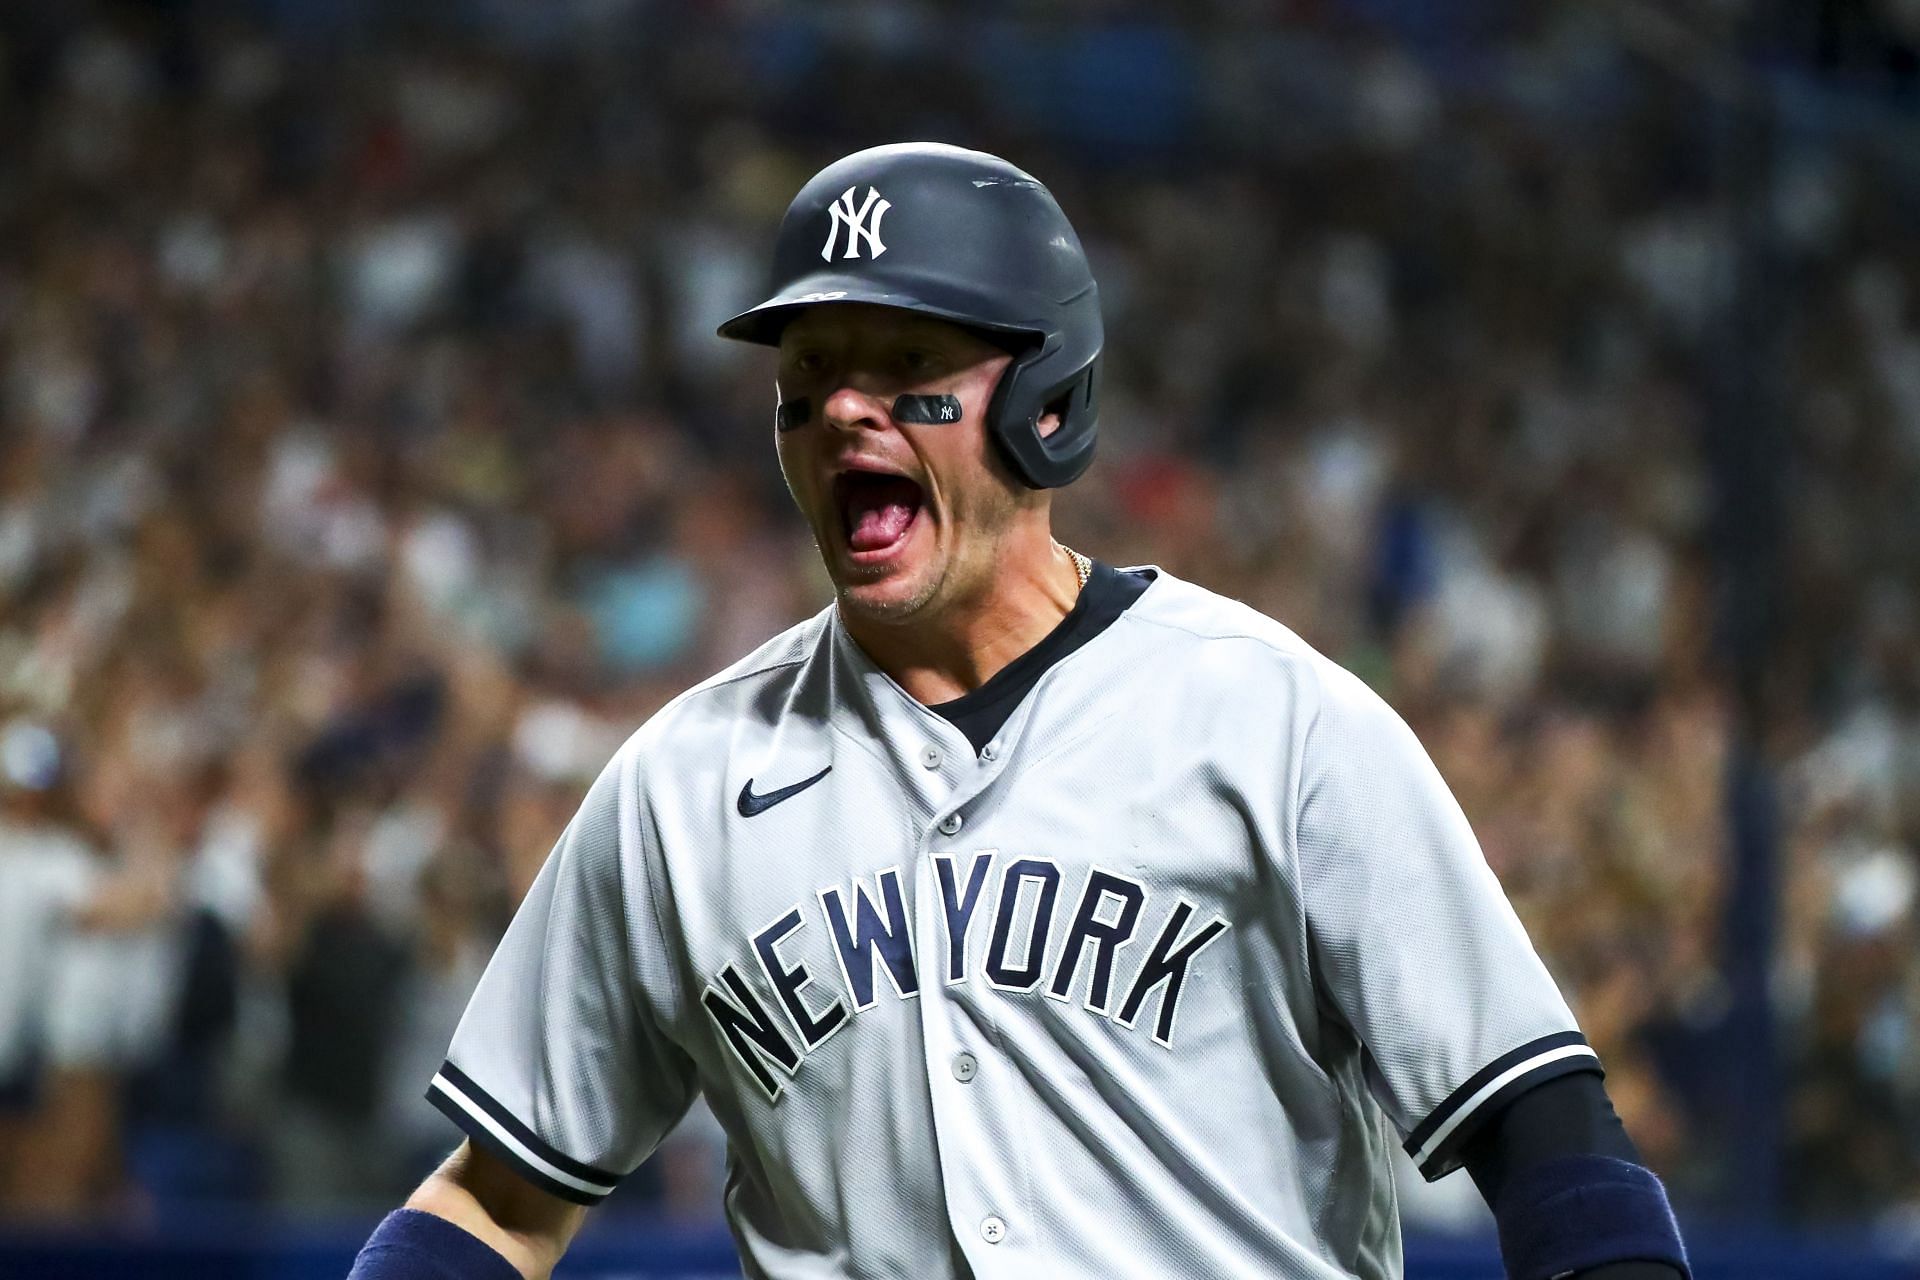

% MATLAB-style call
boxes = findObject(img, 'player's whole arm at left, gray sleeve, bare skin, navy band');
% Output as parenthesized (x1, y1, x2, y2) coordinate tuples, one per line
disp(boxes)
(353, 756, 697, 1280)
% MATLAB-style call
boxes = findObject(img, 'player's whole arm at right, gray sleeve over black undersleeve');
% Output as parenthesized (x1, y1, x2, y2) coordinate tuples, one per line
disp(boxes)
(1294, 672, 1686, 1280)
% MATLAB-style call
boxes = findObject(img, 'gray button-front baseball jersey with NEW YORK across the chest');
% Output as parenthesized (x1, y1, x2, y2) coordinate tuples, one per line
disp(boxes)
(430, 570, 1597, 1280)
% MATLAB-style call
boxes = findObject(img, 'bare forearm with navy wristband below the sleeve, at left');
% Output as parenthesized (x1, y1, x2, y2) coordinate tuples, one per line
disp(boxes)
(348, 1142, 588, 1280)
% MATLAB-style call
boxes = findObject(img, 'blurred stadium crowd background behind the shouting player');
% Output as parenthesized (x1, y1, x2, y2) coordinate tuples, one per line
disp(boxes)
(0, 0, 1920, 1276)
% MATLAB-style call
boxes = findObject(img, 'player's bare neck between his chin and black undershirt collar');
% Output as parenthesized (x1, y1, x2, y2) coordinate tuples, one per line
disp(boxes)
(841, 535, 1079, 706)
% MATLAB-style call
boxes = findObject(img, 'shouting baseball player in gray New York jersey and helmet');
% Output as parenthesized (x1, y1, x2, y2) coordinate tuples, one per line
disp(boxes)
(353, 144, 1686, 1280)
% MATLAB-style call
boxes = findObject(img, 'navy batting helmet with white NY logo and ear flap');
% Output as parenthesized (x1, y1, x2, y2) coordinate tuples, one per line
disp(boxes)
(720, 142, 1104, 489)
